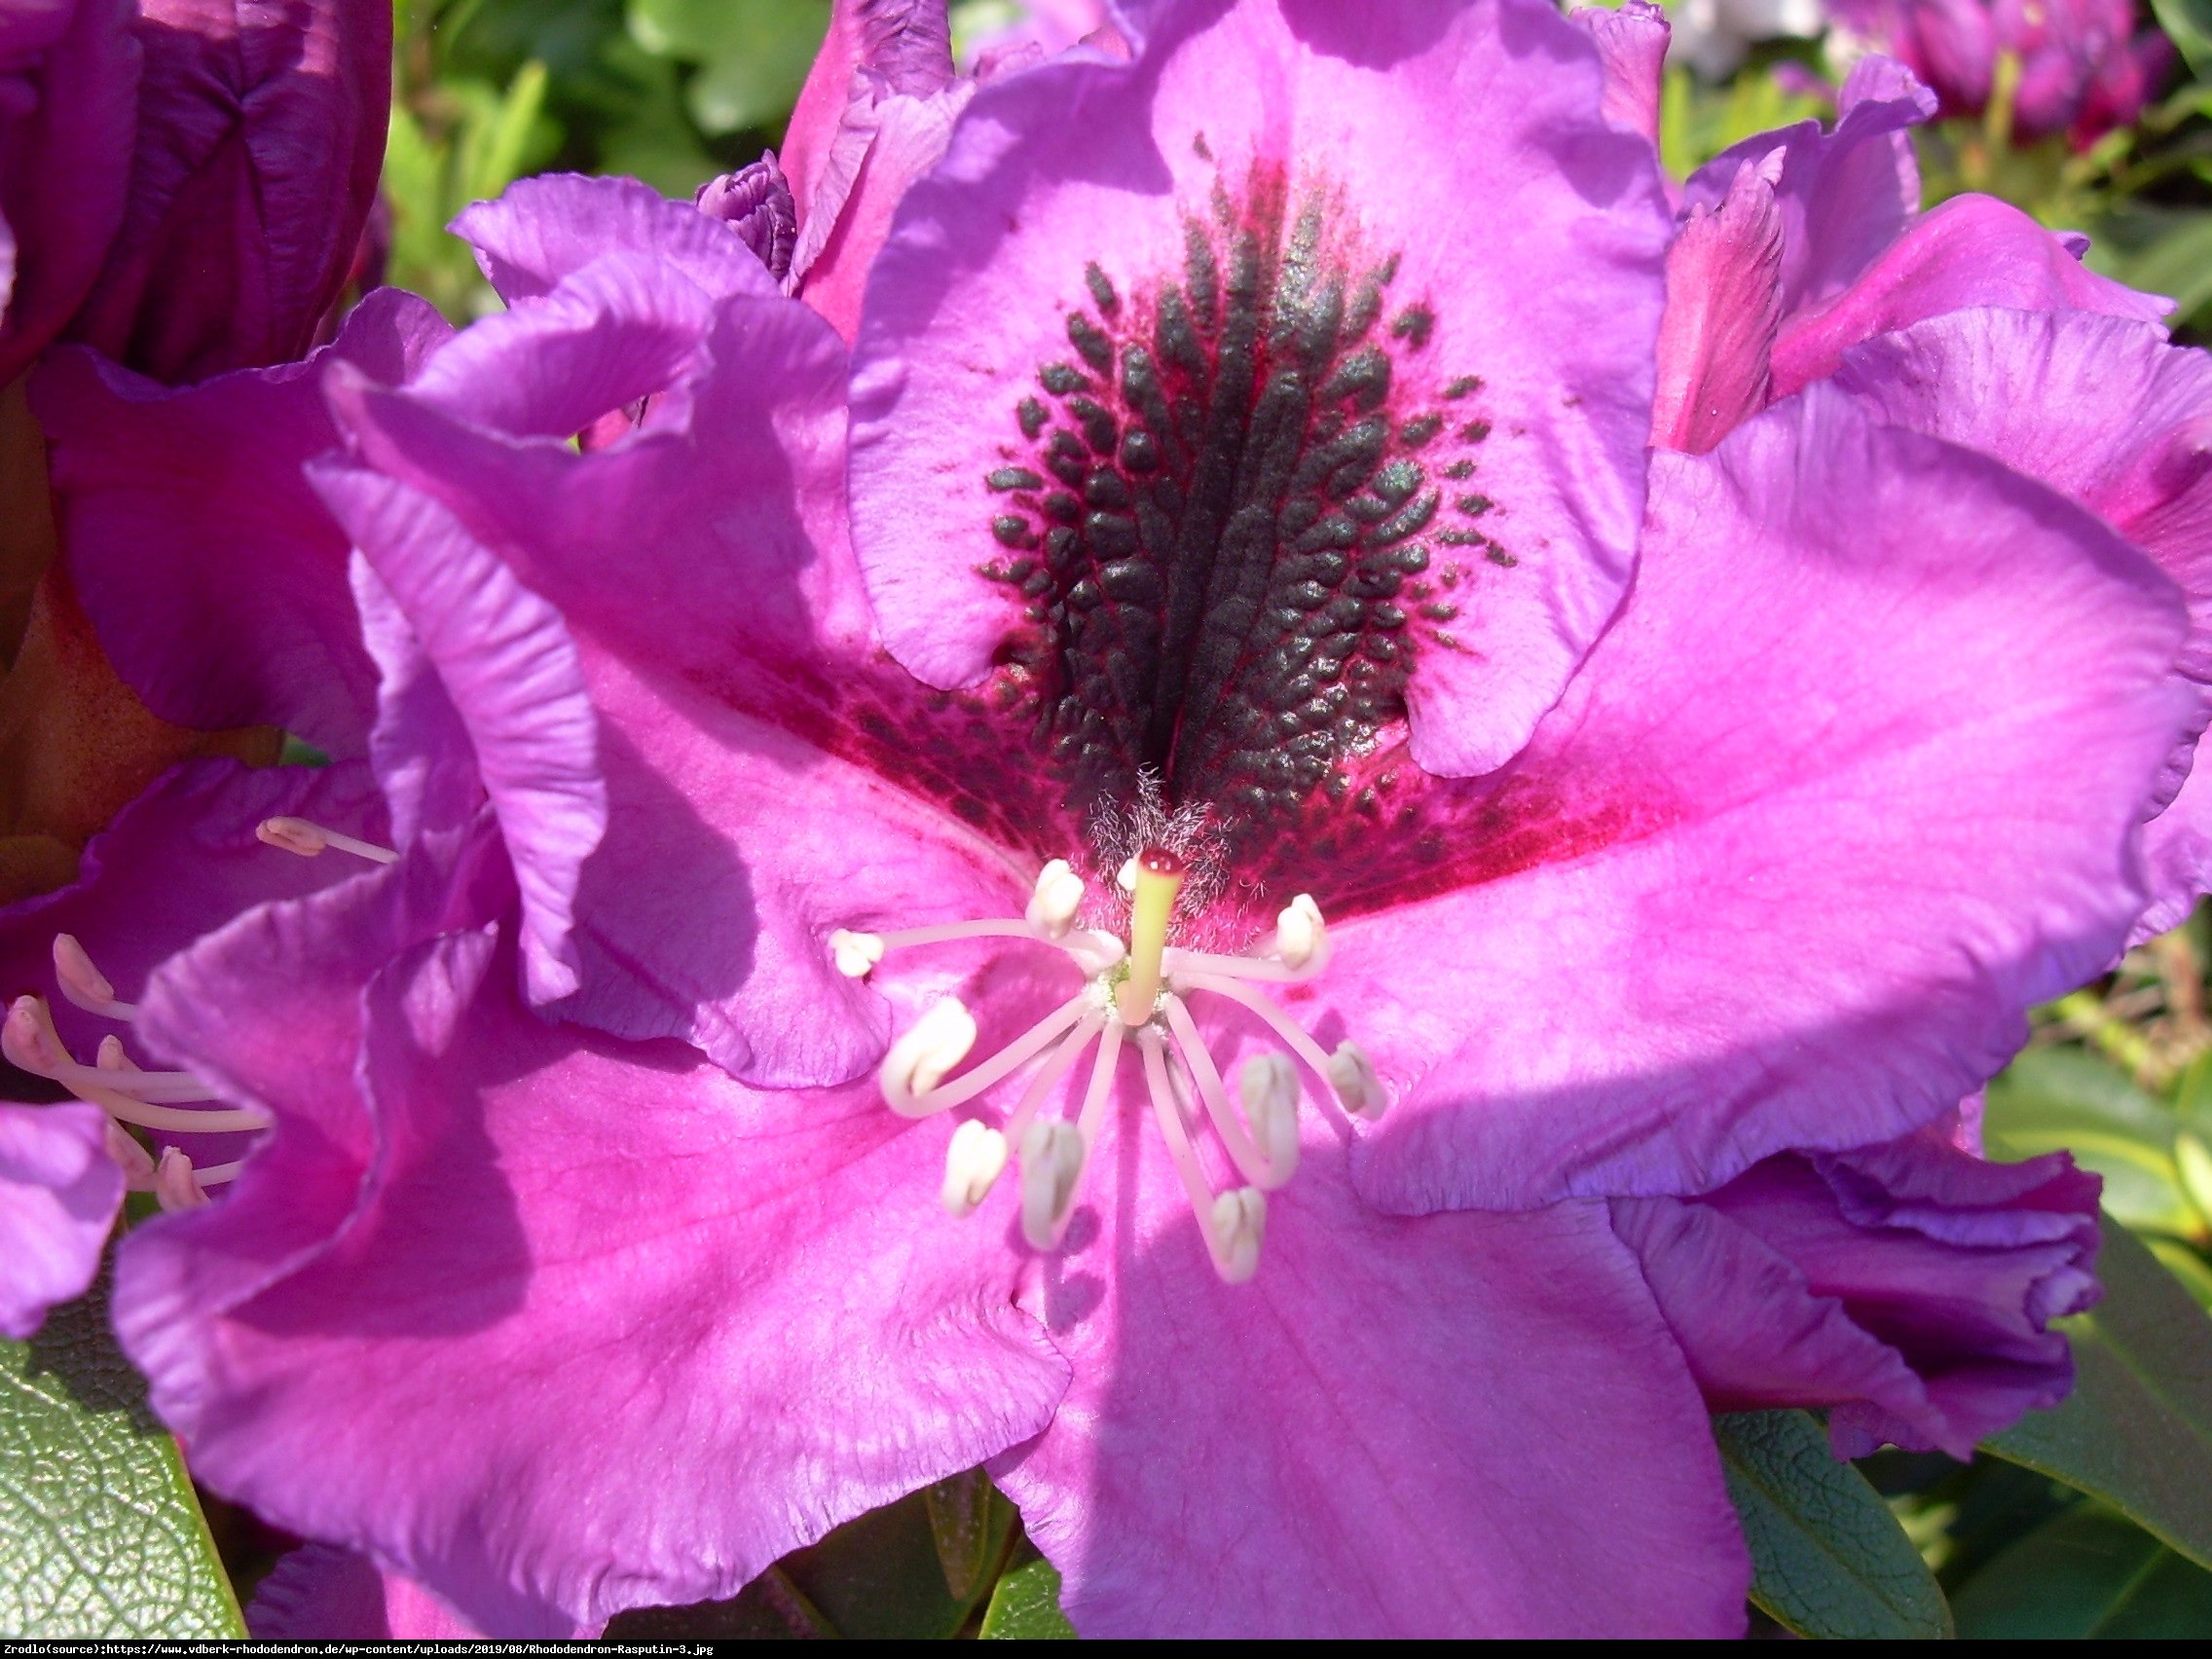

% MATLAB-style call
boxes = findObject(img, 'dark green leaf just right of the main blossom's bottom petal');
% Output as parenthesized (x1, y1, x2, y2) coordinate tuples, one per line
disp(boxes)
(1713, 1412, 1951, 1640)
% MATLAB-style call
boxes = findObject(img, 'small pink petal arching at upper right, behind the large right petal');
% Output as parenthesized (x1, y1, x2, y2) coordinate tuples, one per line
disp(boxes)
(1774, 197, 2172, 396)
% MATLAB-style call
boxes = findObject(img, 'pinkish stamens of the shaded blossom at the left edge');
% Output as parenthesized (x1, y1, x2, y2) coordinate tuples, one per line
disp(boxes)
(0, 819, 398, 1210)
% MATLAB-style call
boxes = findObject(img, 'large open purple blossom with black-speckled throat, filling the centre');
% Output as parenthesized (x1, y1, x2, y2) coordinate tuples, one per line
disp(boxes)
(55, 0, 2194, 1633)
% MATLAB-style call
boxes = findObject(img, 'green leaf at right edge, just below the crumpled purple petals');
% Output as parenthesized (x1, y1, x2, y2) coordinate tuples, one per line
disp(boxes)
(1986, 1217, 2212, 1567)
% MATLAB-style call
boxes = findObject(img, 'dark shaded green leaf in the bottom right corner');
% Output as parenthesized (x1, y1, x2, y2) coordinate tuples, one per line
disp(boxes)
(1951, 1504, 2212, 1637)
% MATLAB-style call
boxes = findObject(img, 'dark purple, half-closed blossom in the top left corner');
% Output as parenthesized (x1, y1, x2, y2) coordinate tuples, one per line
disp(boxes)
(0, 0, 391, 383)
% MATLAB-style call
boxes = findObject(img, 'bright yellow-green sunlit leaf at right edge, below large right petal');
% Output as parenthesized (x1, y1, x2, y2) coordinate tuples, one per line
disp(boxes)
(1982, 1049, 2203, 1235)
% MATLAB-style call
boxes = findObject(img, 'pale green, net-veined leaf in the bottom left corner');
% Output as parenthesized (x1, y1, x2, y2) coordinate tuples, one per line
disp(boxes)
(0, 1290, 245, 1640)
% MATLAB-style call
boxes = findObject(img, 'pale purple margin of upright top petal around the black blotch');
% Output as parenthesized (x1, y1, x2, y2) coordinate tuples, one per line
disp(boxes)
(852, 0, 1666, 772)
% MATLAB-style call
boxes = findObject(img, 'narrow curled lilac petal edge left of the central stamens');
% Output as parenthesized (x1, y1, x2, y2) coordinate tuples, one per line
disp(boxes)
(310, 462, 607, 1002)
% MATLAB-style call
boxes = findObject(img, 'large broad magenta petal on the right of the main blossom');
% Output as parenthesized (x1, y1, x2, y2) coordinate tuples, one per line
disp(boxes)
(1353, 387, 2193, 1210)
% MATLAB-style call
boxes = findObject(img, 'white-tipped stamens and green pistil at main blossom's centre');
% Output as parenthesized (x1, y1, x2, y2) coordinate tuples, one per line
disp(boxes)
(830, 845, 1384, 1283)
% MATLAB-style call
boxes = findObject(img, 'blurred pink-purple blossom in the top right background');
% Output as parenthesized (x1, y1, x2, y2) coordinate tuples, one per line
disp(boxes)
(1827, 0, 2174, 148)
